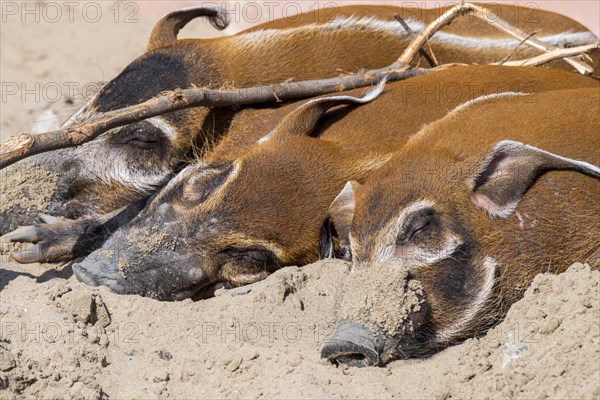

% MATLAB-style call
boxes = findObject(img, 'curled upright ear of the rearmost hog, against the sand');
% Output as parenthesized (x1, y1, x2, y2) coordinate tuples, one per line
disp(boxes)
(146, 5, 229, 51)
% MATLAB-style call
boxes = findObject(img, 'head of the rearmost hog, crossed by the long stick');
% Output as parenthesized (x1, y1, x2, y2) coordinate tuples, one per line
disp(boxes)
(11, 6, 228, 223)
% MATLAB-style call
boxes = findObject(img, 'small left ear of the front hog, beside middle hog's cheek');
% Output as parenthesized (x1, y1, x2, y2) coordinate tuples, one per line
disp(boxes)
(319, 181, 360, 261)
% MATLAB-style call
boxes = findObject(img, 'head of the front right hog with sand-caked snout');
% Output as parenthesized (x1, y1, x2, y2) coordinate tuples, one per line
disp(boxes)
(320, 141, 600, 366)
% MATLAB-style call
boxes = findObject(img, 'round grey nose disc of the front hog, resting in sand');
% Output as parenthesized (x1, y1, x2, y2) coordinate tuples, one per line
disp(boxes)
(321, 322, 383, 368)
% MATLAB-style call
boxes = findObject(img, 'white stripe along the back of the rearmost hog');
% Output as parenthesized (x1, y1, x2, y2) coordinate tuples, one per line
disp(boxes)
(236, 17, 597, 49)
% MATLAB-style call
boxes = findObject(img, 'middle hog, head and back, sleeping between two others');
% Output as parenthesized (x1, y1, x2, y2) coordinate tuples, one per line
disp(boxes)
(22, 66, 596, 299)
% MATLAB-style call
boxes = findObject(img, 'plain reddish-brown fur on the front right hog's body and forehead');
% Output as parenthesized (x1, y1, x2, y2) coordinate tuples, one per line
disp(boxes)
(336, 87, 600, 357)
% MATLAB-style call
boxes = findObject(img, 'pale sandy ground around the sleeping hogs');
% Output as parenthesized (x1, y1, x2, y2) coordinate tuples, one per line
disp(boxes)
(0, 2, 600, 399)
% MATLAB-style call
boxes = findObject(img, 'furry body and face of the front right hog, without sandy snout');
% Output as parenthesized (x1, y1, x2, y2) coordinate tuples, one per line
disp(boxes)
(330, 84, 600, 360)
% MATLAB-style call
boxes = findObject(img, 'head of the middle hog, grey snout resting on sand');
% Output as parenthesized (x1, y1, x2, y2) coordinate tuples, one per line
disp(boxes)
(73, 83, 390, 300)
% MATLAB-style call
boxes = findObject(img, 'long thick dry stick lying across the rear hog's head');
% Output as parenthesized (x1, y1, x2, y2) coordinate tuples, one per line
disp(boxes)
(0, 68, 433, 169)
